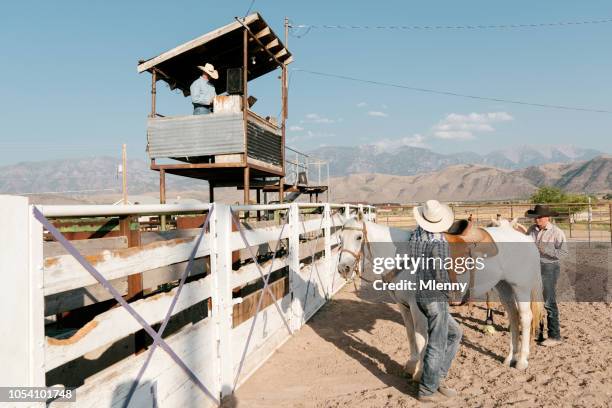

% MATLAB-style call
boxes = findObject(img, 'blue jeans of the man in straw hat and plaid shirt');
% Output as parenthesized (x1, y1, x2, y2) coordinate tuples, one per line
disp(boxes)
(417, 299, 463, 395)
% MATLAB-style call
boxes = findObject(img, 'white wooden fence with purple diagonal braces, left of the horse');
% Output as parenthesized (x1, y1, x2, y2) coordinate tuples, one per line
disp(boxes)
(0, 196, 376, 407)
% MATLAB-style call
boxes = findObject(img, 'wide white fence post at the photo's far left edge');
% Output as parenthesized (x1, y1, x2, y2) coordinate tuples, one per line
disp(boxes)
(0, 195, 45, 387)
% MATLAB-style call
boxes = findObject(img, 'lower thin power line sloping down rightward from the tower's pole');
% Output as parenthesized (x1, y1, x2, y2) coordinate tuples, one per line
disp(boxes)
(292, 68, 612, 113)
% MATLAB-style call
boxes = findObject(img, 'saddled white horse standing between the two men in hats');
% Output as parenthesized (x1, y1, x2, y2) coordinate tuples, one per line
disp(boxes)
(338, 216, 542, 381)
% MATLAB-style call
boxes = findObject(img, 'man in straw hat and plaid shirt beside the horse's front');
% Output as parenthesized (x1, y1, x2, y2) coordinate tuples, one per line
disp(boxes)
(409, 200, 463, 402)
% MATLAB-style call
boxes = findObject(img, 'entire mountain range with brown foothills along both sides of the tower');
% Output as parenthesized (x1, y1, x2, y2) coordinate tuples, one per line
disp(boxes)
(0, 146, 612, 203)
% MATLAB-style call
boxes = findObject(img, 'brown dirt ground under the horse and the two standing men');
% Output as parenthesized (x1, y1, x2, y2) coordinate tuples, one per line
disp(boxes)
(229, 285, 612, 408)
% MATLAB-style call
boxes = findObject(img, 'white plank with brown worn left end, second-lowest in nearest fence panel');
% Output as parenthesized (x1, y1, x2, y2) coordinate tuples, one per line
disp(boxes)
(45, 276, 212, 370)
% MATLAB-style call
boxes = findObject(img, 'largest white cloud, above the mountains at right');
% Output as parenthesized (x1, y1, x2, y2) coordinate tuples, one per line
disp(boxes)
(433, 112, 514, 140)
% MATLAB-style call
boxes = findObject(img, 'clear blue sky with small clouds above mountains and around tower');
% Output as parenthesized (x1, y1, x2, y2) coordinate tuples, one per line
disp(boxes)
(0, 0, 612, 164)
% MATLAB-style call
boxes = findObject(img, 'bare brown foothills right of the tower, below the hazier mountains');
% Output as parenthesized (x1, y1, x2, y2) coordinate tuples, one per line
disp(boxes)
(330, 156, 612, 203)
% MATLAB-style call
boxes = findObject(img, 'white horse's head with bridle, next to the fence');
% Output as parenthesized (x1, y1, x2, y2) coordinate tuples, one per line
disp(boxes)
(338, 214, 367, 279)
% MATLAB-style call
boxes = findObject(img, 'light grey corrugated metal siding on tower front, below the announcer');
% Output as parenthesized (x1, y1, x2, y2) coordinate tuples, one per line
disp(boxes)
(147, 114, 244, 159)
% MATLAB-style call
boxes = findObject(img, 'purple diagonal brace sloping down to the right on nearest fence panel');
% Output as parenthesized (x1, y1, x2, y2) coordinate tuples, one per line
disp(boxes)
(32, 207, 220, 405)
